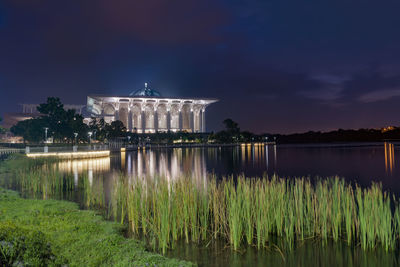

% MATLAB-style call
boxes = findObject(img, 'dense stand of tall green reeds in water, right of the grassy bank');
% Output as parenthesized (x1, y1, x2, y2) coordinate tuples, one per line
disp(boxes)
(111, 176, 400, 252)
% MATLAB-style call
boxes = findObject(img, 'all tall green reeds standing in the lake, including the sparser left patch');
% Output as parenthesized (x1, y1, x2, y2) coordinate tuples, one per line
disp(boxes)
(2, 158, 400, 258)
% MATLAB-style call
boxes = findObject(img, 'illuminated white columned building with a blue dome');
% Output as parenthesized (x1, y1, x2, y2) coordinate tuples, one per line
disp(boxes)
(87, 83, 218, 133)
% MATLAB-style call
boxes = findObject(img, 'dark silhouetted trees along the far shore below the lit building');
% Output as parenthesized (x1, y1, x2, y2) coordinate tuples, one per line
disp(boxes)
(0, 97, 400, 144)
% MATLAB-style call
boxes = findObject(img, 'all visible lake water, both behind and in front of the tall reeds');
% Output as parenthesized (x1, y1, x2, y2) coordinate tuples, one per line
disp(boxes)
(3, 142, 400, 266)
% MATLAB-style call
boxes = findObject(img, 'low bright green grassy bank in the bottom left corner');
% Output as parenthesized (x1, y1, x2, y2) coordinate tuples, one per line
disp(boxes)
(0, 189, 191, 266)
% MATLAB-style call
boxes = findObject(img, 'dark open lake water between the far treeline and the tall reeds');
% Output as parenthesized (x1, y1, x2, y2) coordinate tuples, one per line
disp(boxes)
(102, 143, 400, 194)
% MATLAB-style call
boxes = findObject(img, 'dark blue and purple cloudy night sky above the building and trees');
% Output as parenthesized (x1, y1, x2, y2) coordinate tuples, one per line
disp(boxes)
(0, 0, 400, 133)
